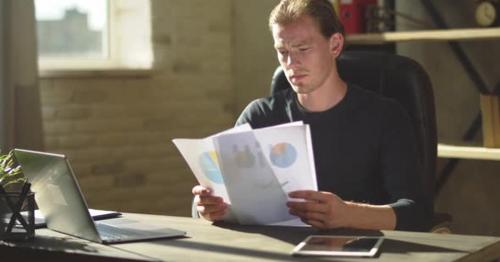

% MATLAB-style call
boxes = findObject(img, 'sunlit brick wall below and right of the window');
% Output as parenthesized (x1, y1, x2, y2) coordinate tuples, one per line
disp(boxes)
(40, 0, 236, 215)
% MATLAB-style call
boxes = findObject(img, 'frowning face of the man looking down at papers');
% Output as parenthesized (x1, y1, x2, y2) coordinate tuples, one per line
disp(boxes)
(272, 16, 342, 94)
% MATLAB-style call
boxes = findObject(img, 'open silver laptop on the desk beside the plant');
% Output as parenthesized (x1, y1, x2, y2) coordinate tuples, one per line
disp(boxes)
(14, 149, 186, 244)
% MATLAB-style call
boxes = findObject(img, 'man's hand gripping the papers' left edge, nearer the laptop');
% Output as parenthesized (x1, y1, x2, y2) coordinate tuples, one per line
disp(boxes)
(193, 185, 227, 221)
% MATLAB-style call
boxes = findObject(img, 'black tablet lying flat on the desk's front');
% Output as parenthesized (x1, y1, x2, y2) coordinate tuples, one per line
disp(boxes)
(292, 235, 384, 257)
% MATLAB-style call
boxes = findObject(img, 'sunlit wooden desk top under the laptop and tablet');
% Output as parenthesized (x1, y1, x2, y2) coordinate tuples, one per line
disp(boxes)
(0, 214, 500, 262)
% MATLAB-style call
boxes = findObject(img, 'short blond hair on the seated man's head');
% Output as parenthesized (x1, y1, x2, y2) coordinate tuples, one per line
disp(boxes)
(269, 0, 344, 38)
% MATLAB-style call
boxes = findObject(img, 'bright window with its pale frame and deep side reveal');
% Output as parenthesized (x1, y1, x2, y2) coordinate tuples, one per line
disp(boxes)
(35, 0, 152, 71)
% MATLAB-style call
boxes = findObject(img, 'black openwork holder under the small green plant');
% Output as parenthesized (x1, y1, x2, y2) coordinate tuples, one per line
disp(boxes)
(0, 187, 35, 241)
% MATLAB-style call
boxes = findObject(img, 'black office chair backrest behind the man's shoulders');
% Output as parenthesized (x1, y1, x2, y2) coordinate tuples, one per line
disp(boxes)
(271, 51, 437, 199)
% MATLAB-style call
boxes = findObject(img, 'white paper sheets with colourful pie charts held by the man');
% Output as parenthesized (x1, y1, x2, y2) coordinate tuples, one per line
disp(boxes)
(173, 122, 317, 225)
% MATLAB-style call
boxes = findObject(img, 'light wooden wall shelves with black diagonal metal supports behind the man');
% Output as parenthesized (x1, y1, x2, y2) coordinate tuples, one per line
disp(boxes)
(346, 22, 500, 195)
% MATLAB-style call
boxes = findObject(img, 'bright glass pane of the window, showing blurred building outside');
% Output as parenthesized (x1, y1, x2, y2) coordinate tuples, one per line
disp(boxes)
(35, 0, 108, 59)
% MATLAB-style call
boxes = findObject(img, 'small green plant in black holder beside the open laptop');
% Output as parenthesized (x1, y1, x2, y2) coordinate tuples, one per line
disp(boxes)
(0, 151, 35, 240)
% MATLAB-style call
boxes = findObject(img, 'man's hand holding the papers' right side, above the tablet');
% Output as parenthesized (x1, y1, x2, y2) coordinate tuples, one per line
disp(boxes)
(287, 190, 348, 229)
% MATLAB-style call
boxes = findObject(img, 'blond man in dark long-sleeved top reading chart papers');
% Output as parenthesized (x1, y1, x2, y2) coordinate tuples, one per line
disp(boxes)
(193, 0, 432, 231)
